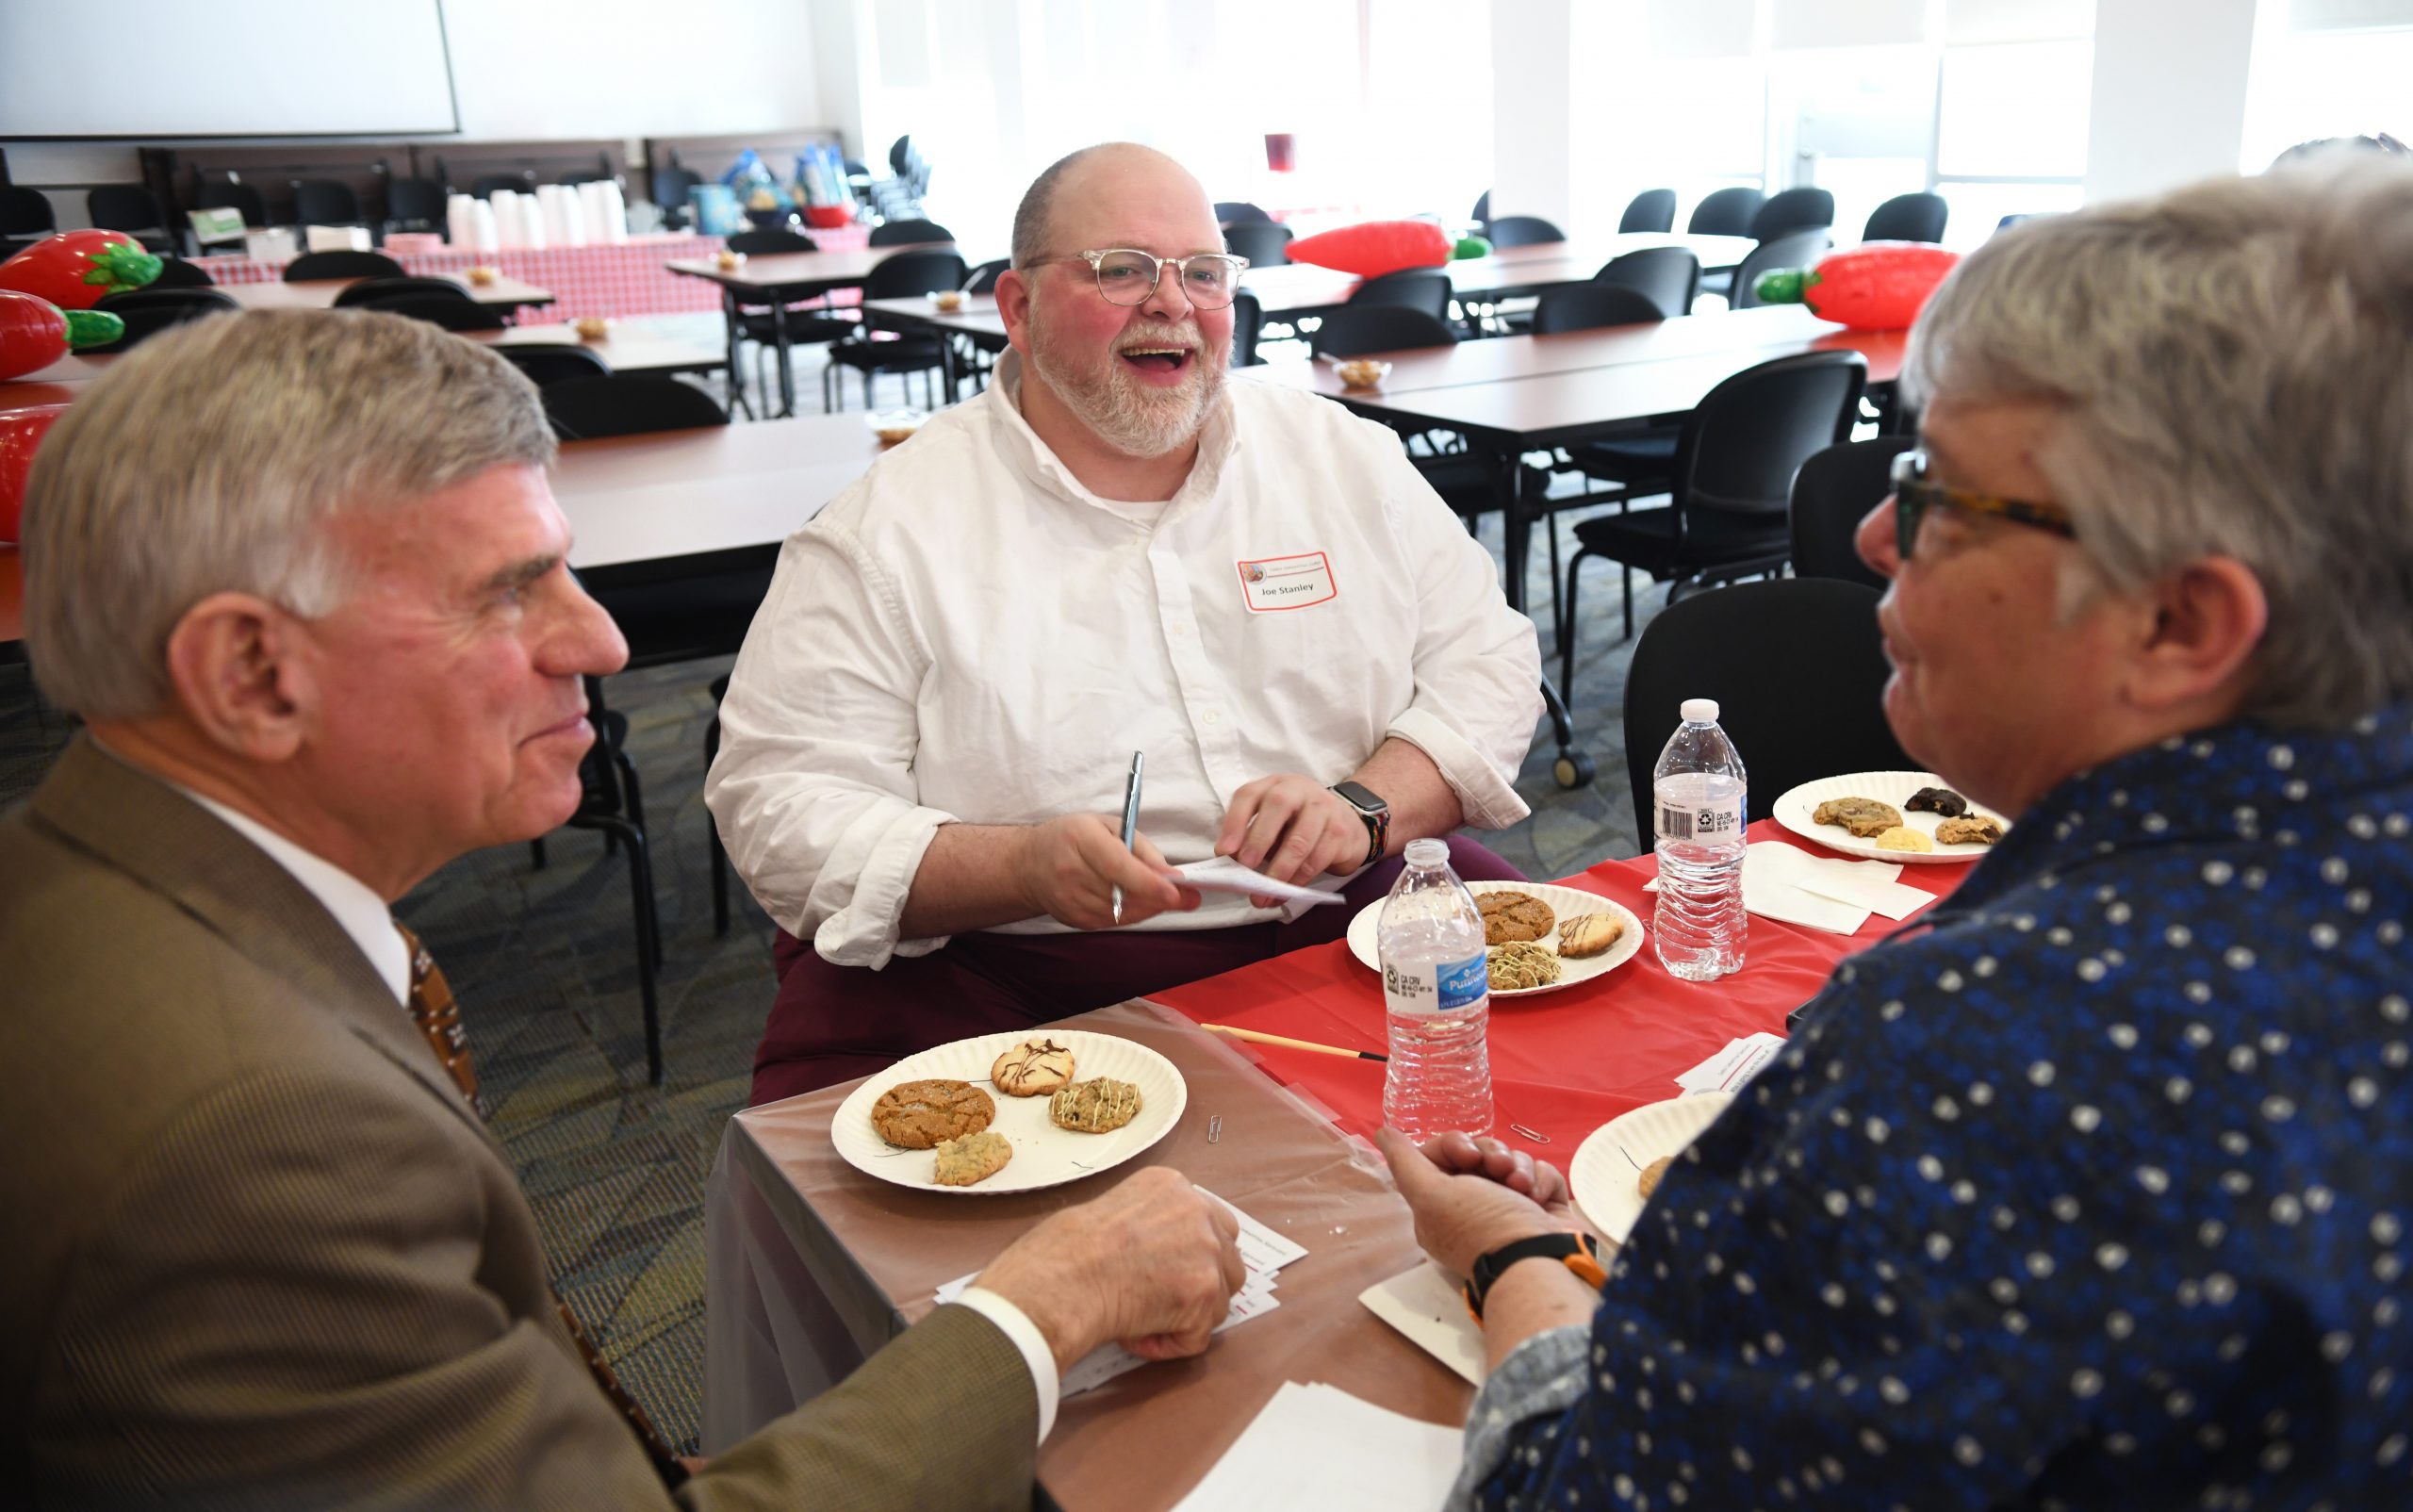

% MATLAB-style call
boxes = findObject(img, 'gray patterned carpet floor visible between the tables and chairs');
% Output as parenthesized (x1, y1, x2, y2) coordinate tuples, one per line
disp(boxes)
(0, 339, 1665, 1444)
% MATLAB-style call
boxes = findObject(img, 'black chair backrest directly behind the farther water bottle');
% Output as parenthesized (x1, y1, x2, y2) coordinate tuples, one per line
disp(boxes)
(1624, 579, 1918, 837)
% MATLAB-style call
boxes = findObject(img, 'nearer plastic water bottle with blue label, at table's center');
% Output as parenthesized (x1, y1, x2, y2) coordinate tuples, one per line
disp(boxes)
(1375, 839, 1491, 1138)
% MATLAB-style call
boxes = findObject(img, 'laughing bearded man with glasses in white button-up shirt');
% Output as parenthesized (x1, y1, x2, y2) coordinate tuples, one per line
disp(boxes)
(707, 144, 1539, 1102)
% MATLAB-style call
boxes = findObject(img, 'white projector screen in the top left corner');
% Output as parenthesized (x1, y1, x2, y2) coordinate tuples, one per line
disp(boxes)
(0, 0, 461, 140)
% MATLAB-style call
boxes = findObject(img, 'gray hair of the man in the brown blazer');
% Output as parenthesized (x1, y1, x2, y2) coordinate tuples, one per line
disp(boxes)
(25, 311, 552, 718)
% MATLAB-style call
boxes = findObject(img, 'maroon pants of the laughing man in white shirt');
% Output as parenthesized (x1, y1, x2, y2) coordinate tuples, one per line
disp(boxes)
(753, 834, 1525, 1105)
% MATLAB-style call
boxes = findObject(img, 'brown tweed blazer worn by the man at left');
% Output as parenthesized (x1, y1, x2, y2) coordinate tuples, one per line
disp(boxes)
(0, 740, 1038, 1512)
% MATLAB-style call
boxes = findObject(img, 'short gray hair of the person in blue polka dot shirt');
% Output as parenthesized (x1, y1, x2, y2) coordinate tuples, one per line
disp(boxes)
(1901, 155, 2413, 729)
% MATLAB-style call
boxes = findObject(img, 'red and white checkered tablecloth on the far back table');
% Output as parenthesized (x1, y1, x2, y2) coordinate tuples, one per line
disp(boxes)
(193, 226, 871, 320)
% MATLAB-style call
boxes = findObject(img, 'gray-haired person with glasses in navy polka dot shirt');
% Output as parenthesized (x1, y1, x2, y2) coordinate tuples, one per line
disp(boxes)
(1383, 159, 2413, 1512)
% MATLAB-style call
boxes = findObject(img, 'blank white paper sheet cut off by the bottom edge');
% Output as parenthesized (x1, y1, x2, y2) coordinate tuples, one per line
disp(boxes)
(1173, 1382, 1465, 1512)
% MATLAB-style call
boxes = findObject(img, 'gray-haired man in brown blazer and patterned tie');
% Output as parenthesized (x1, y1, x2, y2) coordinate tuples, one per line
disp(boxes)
(0, 311, 1240, 1512)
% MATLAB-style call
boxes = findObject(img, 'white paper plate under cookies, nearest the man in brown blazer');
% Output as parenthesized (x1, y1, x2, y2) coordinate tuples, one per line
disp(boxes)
(830, 1029, 1190, 1196)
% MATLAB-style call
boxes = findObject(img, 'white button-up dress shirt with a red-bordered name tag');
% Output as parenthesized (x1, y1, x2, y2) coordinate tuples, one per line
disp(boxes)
(705, 354, 1542, 967)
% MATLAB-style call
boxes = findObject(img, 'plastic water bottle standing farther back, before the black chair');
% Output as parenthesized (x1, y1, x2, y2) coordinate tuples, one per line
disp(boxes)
(1650, 699, 1747, 981)
